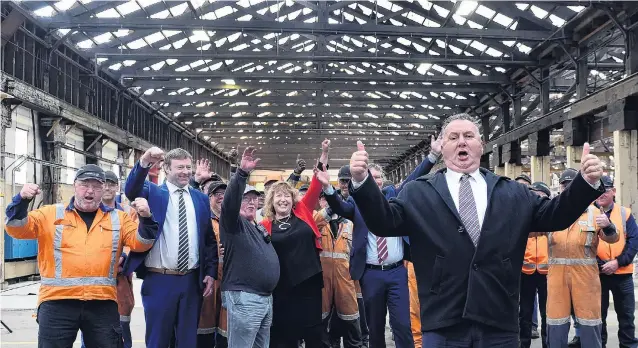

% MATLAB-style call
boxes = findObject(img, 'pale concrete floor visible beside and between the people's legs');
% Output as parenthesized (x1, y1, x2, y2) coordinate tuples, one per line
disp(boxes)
(0, 279, 632, 348)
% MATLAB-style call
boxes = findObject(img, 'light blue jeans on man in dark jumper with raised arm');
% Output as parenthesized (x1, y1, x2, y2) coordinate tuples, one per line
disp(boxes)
(222, 291, 272, 348)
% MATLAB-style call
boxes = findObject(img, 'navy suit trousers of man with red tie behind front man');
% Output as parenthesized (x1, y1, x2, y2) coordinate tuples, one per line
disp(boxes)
(360, 265, 414, 348)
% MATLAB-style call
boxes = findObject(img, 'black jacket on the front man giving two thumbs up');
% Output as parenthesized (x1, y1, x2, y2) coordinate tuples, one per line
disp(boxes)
(350, 168, 604, 332)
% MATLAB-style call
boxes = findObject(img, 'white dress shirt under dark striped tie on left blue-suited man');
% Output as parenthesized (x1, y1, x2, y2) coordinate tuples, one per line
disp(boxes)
(144, 181, 199, 270)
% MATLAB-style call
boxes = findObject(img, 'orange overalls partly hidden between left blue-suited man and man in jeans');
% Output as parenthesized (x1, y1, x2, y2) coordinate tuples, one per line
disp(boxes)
(197, 217, 228, 337)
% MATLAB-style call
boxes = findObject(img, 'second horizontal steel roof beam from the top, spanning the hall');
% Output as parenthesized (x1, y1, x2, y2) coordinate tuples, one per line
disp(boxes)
(104, 49, 543, 66)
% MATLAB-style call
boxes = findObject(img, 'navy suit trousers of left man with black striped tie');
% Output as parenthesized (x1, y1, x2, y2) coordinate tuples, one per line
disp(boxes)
(142, 270, 202, 348)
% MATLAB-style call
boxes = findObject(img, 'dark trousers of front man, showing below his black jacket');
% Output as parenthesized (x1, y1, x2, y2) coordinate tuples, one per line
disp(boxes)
(423, 321, 518, 348)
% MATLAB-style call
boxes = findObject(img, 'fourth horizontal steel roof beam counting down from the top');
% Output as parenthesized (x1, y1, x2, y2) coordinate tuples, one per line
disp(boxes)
(144, 93, 479, 106)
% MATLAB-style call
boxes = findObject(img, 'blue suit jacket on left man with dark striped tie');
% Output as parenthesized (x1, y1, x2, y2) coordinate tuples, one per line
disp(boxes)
(124, 161, 218, 289)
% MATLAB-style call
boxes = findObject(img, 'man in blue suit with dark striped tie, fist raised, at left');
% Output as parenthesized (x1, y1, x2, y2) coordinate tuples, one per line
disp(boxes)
(124, 147, 218, 348)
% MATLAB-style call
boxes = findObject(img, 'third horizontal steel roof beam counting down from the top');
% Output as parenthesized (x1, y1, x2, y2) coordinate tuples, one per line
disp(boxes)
(131, 80, 500, 93)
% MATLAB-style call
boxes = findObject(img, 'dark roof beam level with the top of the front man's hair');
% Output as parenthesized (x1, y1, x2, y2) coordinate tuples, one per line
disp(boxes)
(179, 115, 443, 126)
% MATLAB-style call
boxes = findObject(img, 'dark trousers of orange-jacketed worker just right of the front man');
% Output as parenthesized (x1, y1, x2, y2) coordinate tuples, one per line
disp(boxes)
(518, 272, 547, 348)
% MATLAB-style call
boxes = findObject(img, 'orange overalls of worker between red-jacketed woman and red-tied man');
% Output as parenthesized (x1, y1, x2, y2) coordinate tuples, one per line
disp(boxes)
(314, 210, 359, 321)
